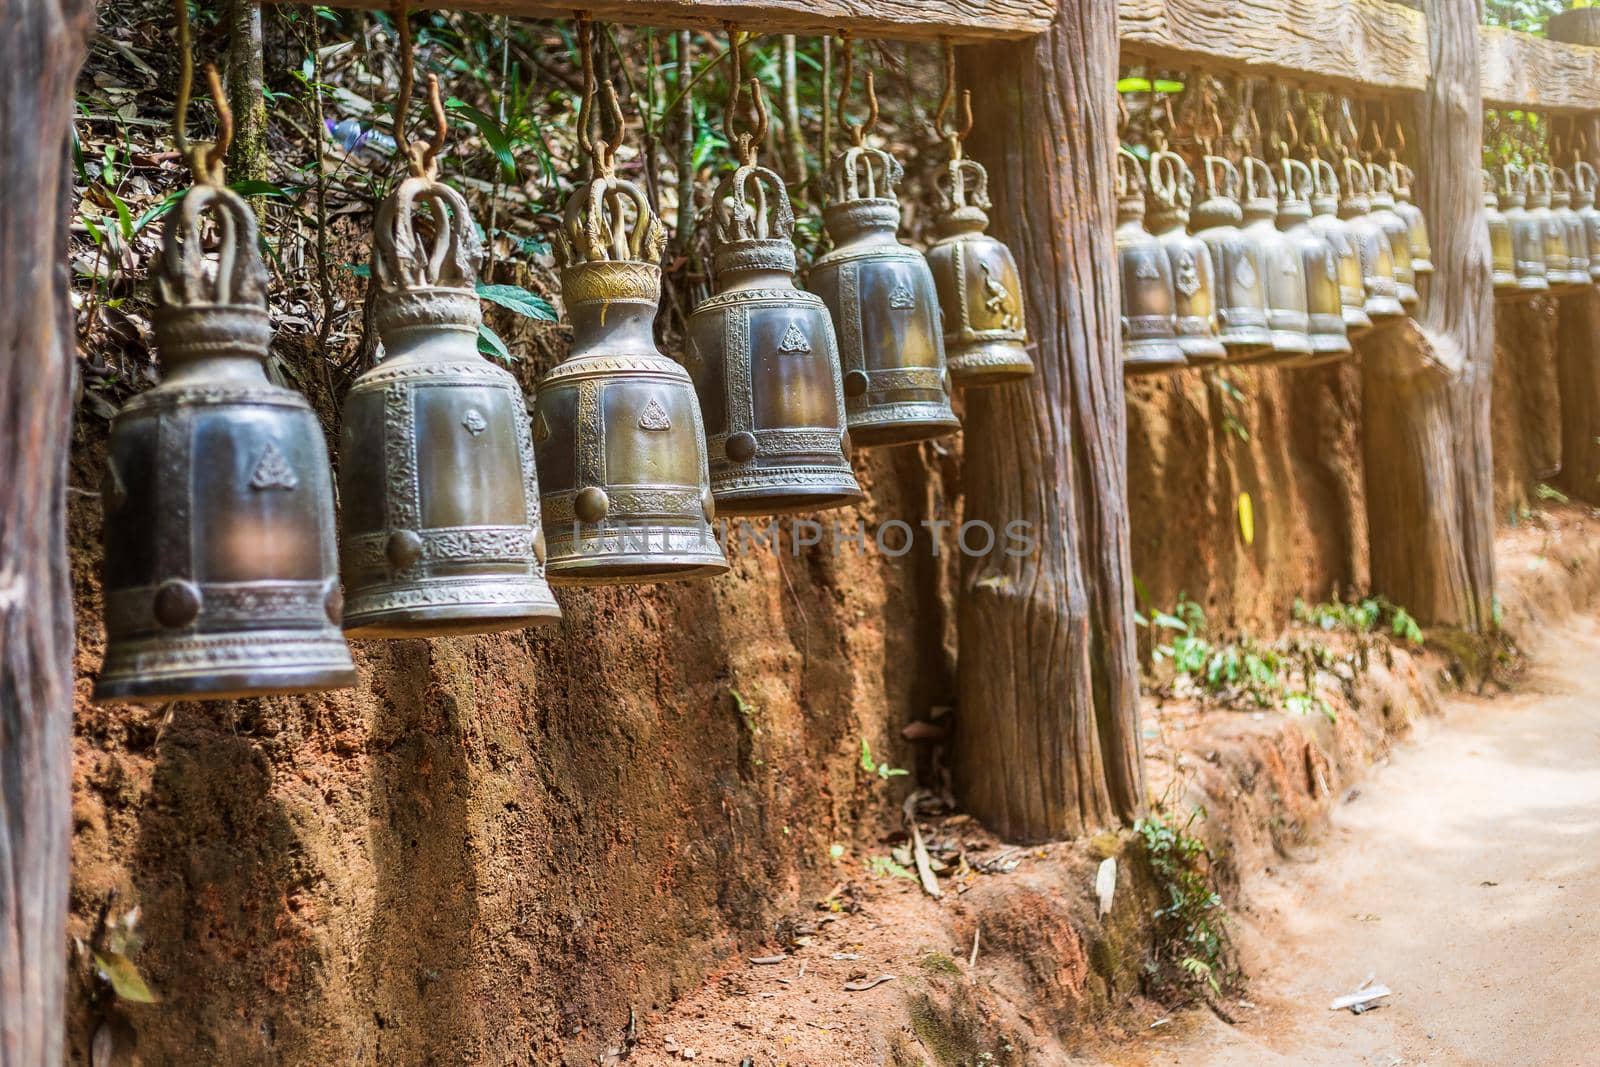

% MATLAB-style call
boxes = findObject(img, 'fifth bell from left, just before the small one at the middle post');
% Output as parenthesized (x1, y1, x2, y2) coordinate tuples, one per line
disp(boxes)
(806, 140, 962, 448)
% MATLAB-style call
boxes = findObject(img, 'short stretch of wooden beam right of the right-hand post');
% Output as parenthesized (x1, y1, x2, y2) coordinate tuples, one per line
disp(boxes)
(1478, 26, 1600, 112)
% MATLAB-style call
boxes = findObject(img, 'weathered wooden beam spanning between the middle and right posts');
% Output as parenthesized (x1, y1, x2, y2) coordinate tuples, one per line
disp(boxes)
(1118, 0, 1429, 94)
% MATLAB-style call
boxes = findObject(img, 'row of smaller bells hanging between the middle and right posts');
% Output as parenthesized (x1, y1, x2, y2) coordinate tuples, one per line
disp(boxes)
(1117, 150, 1434, 374)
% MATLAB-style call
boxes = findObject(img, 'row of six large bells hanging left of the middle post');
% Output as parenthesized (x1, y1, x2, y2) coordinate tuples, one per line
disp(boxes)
(94, 146, 1034, 701)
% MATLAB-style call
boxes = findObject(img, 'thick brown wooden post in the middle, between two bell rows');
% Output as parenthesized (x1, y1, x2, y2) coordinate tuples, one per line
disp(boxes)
(955, 0, 1144, 841)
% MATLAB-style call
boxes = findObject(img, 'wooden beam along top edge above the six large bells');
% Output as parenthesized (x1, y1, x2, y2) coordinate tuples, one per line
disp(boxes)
(265, 0, 1058, 42)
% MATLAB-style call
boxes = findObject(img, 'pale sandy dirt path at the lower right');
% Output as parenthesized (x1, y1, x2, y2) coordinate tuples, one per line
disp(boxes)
(1110, 616, 1600, 1067)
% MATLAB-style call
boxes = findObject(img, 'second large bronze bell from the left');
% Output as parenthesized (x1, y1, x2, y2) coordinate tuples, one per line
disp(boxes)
(339, 178, 562, 637)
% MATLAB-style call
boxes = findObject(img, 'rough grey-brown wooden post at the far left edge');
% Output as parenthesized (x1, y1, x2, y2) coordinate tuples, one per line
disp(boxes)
(0, 0, 93, 1067)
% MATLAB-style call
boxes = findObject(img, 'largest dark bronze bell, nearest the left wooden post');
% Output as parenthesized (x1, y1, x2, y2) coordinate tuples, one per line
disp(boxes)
(94, 184, 355, 702)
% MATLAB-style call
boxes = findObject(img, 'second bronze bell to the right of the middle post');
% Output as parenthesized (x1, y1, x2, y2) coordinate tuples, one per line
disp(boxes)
(1150, 150, 1227, 366)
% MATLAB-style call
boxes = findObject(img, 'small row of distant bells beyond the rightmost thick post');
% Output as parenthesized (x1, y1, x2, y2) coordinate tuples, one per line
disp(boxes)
(1483, 160, 1600, 298)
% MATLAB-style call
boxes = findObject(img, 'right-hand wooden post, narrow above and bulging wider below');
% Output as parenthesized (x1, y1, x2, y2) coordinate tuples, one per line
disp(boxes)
(1362, 0, 1494, 632)
